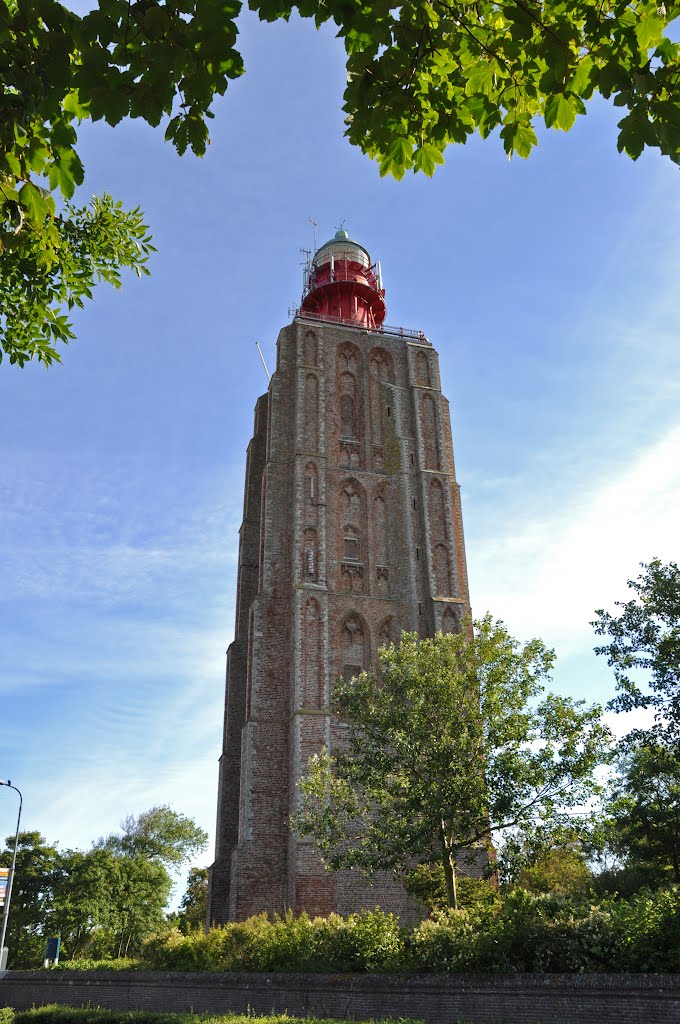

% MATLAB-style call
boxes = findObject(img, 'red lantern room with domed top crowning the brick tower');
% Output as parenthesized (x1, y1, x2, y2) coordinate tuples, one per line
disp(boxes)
(301, 228, 385, 330)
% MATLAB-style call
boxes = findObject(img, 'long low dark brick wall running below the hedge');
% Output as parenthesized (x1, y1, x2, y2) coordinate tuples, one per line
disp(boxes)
(0, 971, 680, 1024)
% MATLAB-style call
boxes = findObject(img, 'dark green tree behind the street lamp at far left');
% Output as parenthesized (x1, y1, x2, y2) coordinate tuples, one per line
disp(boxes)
(0, 831, 58, 968)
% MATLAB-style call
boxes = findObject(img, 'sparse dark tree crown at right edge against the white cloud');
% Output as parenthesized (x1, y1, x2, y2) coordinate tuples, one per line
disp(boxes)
(591, 558, 680, 743)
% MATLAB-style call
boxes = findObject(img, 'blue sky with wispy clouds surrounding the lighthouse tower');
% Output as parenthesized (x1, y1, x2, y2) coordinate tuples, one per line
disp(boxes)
(0, 14, 680, 901)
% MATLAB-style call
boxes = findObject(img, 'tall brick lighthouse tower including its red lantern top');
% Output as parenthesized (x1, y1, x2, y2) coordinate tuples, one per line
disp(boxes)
(208, 230, 469, 924)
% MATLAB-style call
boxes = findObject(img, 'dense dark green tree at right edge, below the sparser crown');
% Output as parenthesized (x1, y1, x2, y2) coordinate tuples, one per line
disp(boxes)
(606, 734, 680, 884)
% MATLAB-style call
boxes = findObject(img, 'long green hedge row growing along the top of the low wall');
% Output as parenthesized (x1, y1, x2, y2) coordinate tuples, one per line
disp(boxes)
(58, 886, 680, 972)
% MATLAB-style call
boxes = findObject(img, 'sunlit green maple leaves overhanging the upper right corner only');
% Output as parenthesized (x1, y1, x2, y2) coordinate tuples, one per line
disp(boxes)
(333, 0, 680, 177)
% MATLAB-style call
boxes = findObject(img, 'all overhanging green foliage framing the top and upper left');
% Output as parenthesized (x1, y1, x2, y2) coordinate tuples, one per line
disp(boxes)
(0, 0, 680, 366)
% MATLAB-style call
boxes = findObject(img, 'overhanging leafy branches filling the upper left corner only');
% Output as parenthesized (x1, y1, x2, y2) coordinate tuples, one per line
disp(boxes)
(0, 0, 243, 366)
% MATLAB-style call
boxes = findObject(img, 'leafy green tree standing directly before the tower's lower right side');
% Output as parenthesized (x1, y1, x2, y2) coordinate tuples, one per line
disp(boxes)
(293, 615, 609, 906)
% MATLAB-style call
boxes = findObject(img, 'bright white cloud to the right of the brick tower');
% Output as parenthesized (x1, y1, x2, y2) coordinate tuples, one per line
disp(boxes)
(468, 426, 680, 656)
